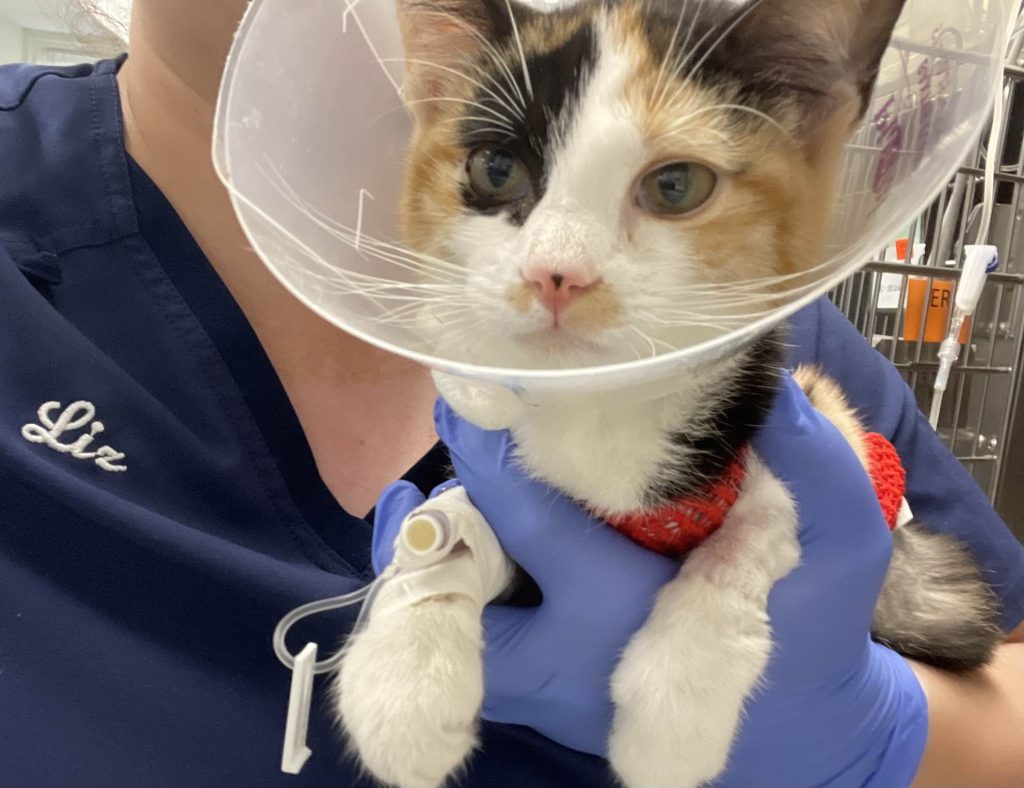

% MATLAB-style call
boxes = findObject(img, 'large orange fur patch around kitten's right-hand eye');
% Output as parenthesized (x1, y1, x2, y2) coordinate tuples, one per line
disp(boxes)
(611, 2, 856, 283)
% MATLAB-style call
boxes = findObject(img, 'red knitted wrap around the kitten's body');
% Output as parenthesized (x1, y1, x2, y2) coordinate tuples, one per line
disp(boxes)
(608, 433, 906, 556)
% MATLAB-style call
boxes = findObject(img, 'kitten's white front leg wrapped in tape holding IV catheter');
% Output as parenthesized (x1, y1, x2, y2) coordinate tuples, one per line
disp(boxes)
(335, 488, 512, 788)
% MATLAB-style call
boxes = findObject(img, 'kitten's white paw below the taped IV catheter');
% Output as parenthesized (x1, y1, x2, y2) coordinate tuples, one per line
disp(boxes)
(335, 585, 483, 788)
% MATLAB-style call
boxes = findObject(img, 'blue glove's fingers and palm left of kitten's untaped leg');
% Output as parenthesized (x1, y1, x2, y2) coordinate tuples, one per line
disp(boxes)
(374, 403, 679, 755)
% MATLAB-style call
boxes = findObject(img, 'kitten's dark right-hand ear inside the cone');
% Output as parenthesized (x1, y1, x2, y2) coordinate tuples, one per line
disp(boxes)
(728, 0, 905, 125)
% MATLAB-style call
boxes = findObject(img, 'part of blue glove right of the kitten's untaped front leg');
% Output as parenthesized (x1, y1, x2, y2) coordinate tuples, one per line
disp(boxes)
(720, 378, 928, 788)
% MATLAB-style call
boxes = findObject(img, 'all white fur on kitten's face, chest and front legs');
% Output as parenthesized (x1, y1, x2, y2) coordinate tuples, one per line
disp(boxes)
(337, 9, 799, 788)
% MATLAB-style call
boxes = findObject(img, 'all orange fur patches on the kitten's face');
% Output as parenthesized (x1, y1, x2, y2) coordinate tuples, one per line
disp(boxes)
(401, 0, 856, 302)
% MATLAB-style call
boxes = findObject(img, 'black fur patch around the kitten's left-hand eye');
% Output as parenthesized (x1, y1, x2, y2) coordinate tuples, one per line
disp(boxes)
(460, 16, 597, 226)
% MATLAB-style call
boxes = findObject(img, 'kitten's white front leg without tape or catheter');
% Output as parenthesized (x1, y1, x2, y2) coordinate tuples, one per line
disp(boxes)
(609, 453, 800, 788)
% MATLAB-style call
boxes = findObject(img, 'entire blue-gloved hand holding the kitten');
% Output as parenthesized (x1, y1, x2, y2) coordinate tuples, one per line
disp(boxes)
(374, 379, 928, 777)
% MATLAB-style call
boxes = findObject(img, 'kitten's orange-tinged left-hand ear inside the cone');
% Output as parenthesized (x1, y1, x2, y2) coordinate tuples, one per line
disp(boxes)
(397, 0, 508, 118)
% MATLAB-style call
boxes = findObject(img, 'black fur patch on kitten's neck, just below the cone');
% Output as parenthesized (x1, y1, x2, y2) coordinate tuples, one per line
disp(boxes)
(646, 327, 785, 509)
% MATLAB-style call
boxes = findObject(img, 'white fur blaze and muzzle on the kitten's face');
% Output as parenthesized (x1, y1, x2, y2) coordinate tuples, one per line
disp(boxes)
(435, 15, 729, 368)
